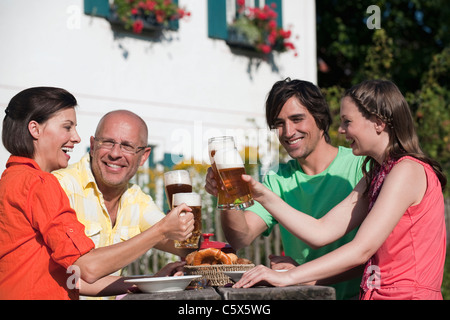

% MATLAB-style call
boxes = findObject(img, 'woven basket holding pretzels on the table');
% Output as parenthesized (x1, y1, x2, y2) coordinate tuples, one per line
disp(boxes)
(184, 264, 255, 287)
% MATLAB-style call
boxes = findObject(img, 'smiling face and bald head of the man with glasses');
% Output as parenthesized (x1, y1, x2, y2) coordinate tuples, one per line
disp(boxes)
(90, 111, 150, 193)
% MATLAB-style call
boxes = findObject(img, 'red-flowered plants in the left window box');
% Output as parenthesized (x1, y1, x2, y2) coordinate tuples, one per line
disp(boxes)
(112, 0, 190, 33)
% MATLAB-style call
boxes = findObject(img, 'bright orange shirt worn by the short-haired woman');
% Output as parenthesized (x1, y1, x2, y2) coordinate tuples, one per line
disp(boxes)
(0, 156, 94, 299)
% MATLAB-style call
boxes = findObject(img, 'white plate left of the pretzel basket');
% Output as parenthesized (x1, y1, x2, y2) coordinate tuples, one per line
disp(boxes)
(125, 275, 202, 292)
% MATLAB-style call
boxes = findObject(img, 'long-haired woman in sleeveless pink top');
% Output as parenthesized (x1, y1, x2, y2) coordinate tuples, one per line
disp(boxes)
(235, 80, 447, 300)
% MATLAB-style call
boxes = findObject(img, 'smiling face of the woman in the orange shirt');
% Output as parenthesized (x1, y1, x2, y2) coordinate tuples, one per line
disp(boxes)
(28, 108, 81, 172)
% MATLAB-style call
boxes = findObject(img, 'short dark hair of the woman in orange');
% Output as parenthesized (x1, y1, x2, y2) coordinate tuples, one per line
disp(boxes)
(2, 87, 77, 158)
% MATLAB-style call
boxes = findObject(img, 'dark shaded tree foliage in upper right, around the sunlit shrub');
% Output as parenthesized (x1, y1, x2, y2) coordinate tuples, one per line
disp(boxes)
(316, 0, 450, 92)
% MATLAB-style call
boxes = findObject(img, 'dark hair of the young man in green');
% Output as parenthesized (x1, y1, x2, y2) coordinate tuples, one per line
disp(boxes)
(266, 78, 332, 143)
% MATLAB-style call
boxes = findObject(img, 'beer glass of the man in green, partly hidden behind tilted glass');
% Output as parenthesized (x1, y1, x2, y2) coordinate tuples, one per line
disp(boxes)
(208, 136, 236, 210)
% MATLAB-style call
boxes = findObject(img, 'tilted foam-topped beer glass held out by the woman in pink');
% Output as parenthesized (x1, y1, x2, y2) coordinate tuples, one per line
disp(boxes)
(214, 148, 254, 210)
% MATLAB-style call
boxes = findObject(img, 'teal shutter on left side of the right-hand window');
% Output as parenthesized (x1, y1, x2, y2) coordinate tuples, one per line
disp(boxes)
(208, 0, 228, 40)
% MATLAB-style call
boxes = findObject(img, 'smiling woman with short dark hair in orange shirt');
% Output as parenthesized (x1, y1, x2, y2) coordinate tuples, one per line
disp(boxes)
(0, 87, 194, 299)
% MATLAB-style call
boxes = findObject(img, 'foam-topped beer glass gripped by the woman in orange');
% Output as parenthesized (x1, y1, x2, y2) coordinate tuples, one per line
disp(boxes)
(172, 192, 202, 248)
